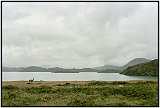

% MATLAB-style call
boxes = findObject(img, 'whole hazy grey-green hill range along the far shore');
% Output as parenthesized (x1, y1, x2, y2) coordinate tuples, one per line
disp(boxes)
(2, 58, 156, 74)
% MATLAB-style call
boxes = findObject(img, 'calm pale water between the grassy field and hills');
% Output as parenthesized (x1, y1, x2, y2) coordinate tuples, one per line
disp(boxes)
(2, 72, 158, 81)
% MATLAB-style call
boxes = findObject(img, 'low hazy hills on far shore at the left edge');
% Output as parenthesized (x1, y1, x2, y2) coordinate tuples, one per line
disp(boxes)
(2, 66, 24, 72)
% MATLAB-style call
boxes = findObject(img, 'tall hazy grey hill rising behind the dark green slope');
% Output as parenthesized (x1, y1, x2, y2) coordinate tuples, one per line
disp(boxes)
(120, 58, 151, 71)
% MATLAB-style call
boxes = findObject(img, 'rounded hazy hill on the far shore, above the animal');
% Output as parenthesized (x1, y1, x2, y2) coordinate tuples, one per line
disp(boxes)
(20, 66, 48, 72)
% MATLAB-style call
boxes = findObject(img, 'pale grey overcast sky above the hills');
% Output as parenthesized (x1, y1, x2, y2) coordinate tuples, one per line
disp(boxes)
(2, 2, 158, 68)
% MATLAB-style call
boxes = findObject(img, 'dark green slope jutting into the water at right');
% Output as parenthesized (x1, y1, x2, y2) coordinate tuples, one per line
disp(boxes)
(121, 59, 158, 77)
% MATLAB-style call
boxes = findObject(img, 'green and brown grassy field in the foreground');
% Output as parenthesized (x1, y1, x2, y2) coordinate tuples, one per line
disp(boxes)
(2, 81, 158, 106)
